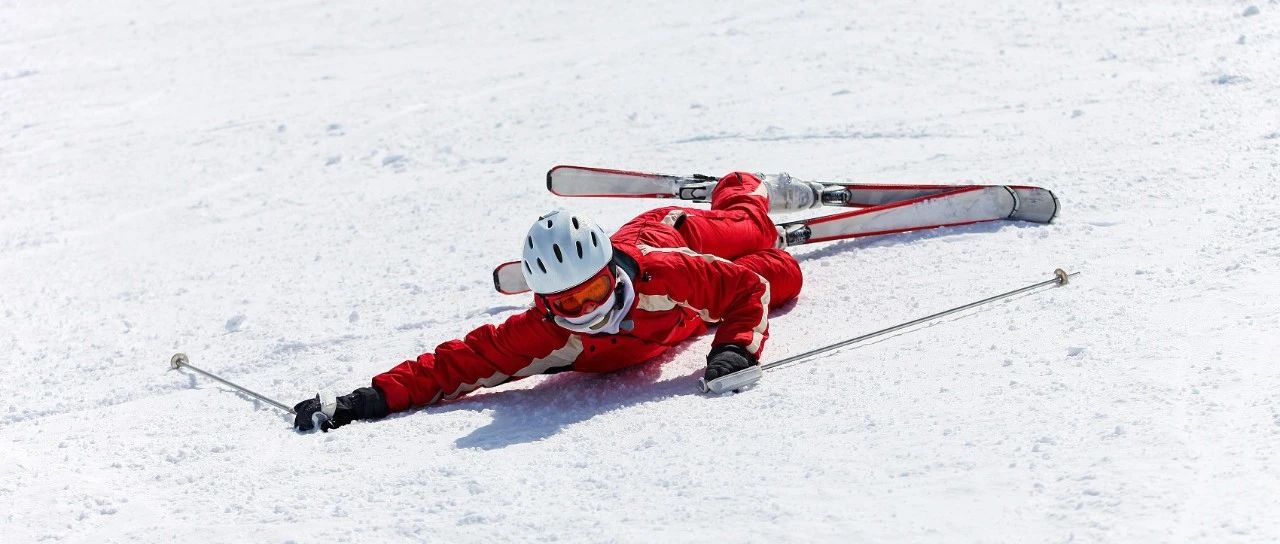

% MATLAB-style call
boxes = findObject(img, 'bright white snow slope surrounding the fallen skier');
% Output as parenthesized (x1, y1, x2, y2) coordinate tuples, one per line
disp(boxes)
(0, 0, 1280, 543)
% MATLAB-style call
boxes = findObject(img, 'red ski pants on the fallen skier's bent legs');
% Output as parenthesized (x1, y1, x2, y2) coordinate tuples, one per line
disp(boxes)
(619, 172, 804, 310)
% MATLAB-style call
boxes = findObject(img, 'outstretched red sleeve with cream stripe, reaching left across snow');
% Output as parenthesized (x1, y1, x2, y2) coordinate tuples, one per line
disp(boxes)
(374, 307, 582, 412)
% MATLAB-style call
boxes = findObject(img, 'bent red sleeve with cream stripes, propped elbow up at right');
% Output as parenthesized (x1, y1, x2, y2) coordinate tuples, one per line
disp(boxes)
(637, 246, 769, 357)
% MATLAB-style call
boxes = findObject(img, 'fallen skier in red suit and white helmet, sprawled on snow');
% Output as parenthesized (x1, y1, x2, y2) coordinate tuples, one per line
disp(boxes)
(293, 173, 822, 430)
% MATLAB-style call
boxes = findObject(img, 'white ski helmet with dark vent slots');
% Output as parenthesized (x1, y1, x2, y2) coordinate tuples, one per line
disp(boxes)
(521, 211, 613, 294)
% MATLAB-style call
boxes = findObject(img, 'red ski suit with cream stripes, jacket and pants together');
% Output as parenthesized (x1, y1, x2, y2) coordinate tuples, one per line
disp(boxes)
(374, 173, 801, 412)
